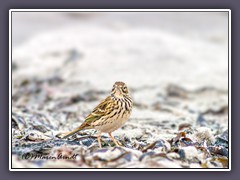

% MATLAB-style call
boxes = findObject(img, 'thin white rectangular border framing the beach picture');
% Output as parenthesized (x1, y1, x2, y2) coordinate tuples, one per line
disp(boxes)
(9, 9, 232, 171)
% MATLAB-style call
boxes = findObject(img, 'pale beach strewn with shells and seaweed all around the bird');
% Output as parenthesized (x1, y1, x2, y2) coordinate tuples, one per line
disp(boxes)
(12, 12, 228, 168)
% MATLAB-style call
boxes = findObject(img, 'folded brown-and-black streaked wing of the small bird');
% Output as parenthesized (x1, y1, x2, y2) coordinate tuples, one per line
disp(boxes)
(81, 96, 116, 128)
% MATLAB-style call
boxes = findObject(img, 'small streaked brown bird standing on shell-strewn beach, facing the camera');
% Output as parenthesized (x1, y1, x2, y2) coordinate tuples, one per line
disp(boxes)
(57, 82, 133, 148)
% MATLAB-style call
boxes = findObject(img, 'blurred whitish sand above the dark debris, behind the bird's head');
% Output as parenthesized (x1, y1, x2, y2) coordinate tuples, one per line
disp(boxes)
(12, 12, 228, 90)
